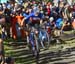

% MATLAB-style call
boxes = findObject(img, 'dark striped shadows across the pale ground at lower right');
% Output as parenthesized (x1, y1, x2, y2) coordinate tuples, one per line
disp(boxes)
(39, 47, 75, 64)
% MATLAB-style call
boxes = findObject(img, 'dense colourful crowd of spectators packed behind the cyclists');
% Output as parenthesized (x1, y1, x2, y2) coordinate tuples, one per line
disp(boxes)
(0, 0, 75, 39)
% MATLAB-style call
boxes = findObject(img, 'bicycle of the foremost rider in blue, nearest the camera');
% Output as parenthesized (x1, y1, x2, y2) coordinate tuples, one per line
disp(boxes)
(27, 28, 40, 59)
